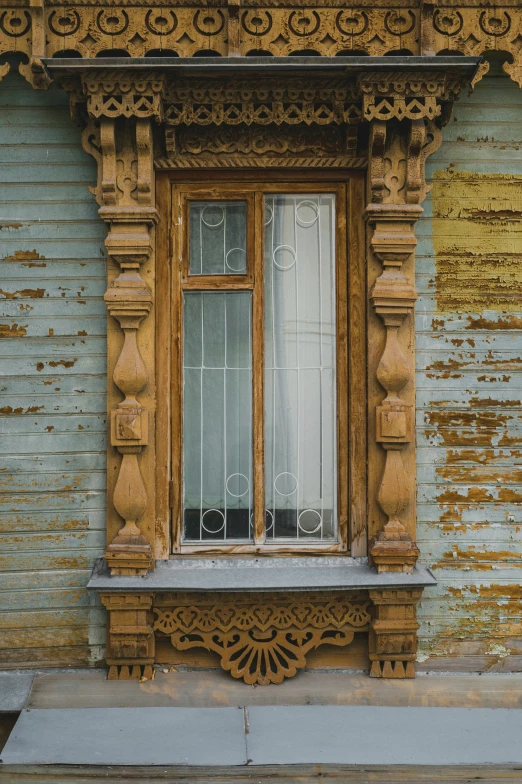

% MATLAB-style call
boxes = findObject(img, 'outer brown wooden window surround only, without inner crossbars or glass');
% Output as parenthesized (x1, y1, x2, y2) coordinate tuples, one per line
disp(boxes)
(156, 173, 367, 558)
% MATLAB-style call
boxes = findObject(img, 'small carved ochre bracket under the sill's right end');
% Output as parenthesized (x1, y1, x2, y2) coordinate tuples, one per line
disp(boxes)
(369, 589, 422, 678)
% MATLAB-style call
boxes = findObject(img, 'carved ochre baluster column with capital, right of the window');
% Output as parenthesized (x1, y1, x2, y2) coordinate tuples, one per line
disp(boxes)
(359, 73, 460, 572)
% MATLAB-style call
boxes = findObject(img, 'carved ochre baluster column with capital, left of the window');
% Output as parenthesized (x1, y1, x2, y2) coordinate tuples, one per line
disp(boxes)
(74, 72, 163, 575)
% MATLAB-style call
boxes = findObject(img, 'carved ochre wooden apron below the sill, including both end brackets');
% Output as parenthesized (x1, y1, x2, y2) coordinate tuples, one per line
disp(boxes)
(101, 589, 422, 684)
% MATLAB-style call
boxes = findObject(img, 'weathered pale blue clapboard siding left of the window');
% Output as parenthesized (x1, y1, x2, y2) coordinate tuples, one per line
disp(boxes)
(0, 66, 107, 667)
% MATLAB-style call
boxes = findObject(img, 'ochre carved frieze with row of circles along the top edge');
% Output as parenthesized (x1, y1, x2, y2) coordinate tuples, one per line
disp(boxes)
(0, 0, 522, 89)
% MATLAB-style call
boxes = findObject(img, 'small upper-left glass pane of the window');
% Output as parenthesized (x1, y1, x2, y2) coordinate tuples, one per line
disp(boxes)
(190, 201, 247, 275)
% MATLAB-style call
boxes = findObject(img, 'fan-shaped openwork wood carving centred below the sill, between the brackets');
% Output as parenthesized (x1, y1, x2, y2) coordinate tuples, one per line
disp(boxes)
(154, 593, 370, 684)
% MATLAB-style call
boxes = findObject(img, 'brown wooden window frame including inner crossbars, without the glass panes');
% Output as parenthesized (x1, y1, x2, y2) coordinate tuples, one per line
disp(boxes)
(156, 171, 367, 557)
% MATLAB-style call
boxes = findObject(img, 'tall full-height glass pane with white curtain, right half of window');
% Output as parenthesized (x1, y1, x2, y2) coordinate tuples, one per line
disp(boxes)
(264, 194, 337, 541)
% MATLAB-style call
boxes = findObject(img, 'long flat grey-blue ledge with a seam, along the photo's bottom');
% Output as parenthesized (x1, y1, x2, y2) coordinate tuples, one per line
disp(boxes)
(3, 705, 522, 764)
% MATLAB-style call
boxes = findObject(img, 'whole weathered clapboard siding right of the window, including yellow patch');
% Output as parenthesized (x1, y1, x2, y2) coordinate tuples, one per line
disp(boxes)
(416, 76, 522, 671)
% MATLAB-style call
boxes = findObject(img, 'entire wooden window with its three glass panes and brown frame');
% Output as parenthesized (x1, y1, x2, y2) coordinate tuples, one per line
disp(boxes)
(159, 175, 365, 554)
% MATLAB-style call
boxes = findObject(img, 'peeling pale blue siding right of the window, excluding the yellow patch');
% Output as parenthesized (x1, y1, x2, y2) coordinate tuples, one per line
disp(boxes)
(415, 77, 522, 671)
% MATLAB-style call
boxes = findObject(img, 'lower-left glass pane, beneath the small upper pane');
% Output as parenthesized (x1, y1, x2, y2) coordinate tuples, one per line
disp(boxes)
(183, 291, 253, 542)
